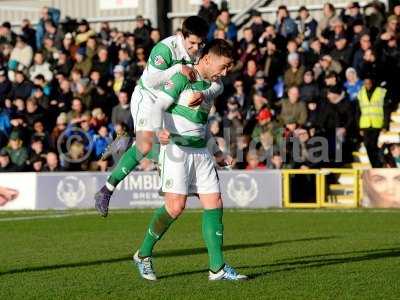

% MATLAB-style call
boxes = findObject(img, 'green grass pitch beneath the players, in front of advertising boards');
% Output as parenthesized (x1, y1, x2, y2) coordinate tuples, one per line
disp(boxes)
(0, 210, 400, 300)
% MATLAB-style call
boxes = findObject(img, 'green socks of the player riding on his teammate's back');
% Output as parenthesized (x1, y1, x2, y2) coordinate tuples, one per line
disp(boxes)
(107, 144, 160, 188)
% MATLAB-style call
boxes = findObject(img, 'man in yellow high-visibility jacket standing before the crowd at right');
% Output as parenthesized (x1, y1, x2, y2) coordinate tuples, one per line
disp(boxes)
(357, 76, 387, 168)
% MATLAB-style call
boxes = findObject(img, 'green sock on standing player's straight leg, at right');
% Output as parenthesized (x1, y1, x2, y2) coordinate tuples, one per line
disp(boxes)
(203, 208, 224, 273)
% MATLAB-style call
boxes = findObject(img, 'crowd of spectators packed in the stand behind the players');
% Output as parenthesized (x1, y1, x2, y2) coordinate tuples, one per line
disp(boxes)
(0, 0, 400, 172)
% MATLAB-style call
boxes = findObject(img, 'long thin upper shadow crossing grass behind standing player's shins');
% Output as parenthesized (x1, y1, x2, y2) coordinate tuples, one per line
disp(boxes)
(0, 236, 338, 277)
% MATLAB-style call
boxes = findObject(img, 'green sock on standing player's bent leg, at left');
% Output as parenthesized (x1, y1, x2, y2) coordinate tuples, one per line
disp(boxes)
(139, 205, 175, 257)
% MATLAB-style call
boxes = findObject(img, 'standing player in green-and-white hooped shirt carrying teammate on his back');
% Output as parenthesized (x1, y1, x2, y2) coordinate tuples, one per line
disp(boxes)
(134, 39, 247, 280)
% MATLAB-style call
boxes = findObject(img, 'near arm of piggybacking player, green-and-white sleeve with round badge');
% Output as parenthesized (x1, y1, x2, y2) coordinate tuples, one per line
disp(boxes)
(146, 43, 193, 88)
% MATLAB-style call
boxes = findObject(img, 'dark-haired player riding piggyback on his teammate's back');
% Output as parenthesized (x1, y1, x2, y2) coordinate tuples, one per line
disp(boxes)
(95, 16, 223, 217)
